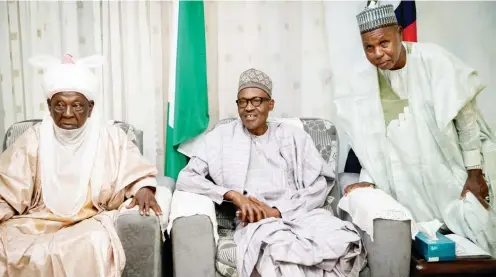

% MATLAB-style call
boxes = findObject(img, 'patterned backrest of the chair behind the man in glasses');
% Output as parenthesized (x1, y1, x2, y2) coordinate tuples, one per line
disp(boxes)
(212, 118, 341, 215)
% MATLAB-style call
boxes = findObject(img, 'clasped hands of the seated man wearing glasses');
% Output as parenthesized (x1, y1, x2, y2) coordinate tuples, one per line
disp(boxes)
(224, 190, 267, 226)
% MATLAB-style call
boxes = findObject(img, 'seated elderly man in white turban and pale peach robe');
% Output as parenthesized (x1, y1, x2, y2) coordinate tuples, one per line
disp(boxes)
(0, 55, 161, 277)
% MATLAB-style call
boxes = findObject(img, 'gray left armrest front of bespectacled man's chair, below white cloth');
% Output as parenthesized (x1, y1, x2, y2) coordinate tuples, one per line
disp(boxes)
(171, 215, 216, 277)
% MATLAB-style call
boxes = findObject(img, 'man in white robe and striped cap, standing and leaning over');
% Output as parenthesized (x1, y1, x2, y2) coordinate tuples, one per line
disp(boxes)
(336, 1, 496, 256)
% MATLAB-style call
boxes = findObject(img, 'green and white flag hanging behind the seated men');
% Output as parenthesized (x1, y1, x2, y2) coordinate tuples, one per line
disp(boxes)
(165, 0, 209, 179)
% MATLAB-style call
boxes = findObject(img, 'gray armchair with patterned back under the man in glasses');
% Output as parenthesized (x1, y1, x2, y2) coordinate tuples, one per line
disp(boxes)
(171, 118, 411, 277)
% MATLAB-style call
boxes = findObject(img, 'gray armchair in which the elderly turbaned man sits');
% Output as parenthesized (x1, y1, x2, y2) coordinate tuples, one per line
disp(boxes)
(2, 119, 166, 277)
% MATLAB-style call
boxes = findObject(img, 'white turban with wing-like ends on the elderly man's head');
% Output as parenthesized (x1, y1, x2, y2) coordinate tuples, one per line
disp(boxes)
(29, 54, 103, 100)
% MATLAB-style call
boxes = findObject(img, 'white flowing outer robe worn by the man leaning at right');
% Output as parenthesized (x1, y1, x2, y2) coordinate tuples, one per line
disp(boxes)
(335, 43, 496, 255)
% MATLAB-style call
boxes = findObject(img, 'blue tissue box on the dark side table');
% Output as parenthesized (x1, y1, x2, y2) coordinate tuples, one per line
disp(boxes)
(413, 232, 456, 262)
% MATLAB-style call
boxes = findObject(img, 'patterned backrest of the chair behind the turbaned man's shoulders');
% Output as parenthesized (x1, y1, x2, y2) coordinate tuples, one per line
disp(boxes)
(2, 119, 143, 154)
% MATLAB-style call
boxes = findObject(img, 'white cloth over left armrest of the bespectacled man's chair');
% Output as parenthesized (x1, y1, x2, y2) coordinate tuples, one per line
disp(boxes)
(167, 190, 219, 245)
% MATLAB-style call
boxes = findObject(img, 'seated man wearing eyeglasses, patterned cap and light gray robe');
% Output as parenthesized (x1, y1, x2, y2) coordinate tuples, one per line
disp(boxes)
(176, 68, 365, 277)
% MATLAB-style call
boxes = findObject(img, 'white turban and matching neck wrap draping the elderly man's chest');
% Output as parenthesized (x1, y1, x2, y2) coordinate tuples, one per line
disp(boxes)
(30, 55, 103, 218)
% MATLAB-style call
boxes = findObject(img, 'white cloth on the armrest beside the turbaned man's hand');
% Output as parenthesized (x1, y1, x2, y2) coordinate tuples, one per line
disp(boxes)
(119, 181, 172, 241)
